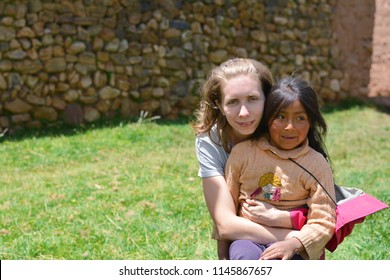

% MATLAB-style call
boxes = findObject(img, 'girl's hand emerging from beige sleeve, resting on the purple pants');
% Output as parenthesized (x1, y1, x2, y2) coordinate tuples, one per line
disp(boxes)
(260, 238, 304, 260)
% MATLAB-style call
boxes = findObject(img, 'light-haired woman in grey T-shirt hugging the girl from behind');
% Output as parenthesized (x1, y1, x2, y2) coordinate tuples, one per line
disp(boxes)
(193, 58, 296, 259)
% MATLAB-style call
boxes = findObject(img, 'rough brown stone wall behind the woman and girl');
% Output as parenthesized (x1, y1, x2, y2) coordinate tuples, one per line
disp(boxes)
(0, 0, 373, 131)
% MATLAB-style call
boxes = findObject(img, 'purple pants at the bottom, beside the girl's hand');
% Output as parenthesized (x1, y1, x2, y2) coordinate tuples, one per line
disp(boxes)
(229, 240, 303, 260)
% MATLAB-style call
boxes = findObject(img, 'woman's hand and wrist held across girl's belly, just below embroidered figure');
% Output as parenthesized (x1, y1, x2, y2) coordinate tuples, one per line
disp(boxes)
(241, 199, 292, 228)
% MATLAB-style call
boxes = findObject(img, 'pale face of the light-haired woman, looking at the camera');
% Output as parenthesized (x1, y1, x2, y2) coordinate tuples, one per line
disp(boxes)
(220, 75, 265, 145)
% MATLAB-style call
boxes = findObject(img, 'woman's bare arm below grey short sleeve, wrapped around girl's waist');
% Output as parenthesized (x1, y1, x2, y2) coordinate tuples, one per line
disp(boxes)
(202, 176, 297, 244)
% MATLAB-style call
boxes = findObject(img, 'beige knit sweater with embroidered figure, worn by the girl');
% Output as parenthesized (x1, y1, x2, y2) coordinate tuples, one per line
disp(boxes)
(225, 138, 336, 260)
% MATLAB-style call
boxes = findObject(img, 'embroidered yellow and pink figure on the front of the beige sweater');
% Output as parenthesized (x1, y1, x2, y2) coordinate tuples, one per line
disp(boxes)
(251, 172, 282, 201)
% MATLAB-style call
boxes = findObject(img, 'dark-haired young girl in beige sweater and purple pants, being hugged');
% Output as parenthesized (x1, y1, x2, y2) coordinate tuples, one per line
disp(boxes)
(225, 78, 336, 260)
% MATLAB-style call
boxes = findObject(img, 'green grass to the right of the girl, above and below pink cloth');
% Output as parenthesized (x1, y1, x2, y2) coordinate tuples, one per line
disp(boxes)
(326, 105, 390, 260)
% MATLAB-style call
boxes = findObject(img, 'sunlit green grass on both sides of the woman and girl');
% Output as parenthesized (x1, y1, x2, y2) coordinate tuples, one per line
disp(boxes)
(0, 101, 390, 260)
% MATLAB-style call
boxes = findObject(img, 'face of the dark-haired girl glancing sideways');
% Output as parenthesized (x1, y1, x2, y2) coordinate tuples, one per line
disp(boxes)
(269, 100, 310, 150)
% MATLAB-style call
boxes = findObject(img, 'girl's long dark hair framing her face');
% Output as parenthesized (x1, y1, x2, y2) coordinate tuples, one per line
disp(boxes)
(256, 77, 330, 162)
